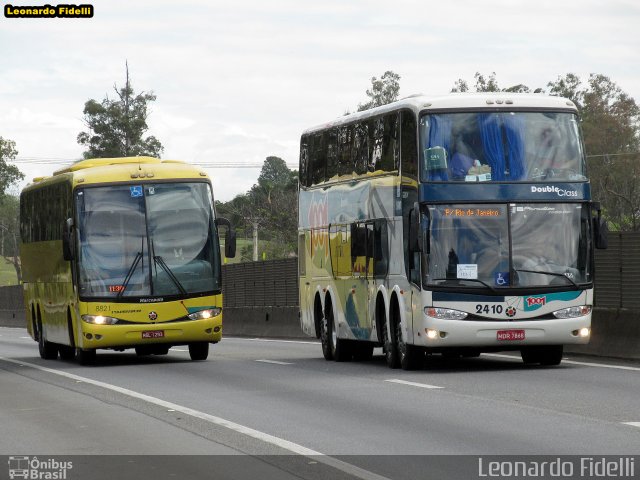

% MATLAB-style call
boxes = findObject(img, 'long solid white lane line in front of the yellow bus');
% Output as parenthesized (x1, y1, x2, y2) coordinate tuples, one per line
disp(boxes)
(0, 357, 390, 480)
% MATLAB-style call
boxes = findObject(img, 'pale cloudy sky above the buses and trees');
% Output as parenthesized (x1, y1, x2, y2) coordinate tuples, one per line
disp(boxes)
(0, 0, 640, 201)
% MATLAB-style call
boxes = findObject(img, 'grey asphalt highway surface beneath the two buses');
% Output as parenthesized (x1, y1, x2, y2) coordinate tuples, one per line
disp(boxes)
(0, 328, 640, 479)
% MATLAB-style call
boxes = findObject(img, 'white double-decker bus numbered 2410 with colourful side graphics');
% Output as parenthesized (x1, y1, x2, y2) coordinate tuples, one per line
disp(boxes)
(299, 93, 606, 369)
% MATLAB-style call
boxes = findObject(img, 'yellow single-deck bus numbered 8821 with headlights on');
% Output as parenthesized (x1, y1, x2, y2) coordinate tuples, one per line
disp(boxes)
(20, 157, 236, 364)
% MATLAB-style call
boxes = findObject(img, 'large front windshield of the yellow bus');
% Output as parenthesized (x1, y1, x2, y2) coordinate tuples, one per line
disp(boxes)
(76, 183, 220, 300)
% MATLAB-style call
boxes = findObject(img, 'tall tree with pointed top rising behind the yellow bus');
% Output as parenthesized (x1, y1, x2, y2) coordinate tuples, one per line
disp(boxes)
(78, 65, 164, 158)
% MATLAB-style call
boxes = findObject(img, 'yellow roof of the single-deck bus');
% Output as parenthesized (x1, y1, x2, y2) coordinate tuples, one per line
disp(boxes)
(25, 157, 208, 190)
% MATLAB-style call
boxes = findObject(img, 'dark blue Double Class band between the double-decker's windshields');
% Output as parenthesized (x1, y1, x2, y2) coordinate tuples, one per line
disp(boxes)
(420, 183, 591, 203)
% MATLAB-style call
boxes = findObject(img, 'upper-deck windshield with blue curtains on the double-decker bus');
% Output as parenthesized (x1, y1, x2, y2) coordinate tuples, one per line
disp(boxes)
(420, 112, 587, 182)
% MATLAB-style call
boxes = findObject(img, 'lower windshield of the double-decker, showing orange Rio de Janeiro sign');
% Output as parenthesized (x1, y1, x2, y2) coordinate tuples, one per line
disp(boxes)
(422, 203, 592, 290)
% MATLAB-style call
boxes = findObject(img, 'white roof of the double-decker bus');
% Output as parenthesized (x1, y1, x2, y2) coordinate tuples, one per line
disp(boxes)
(303, 92, 578, 135)
